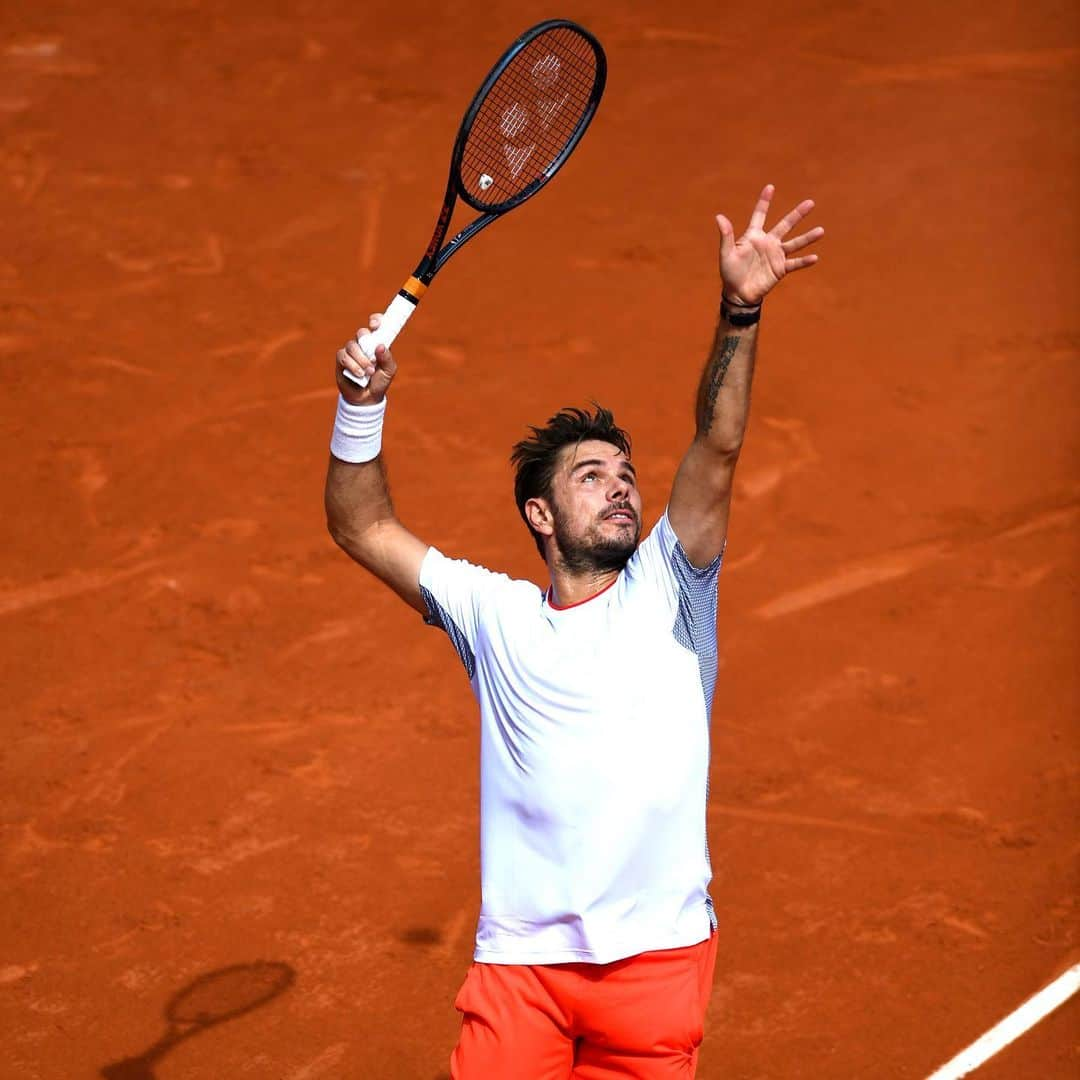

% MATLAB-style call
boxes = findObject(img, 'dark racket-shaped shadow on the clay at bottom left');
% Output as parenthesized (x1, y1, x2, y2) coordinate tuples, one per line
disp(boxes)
(100, 960, 296, 1080)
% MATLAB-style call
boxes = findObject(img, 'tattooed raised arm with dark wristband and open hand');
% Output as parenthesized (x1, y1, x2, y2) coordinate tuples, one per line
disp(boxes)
(667, 184, 825, 566)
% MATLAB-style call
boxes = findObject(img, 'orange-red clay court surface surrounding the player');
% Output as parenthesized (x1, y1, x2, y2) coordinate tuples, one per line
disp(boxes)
(0, 0, 1080, 1080)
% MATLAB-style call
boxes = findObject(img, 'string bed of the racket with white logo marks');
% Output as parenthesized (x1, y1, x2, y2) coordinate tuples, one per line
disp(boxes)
(460, 27, 598, 207)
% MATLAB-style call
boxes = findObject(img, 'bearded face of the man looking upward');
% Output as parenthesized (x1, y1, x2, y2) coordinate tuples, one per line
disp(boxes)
(550, 440, 642, 571)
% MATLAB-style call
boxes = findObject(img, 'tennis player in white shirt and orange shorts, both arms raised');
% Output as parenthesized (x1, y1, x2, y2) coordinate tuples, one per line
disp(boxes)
(326, 185, 824, 1080)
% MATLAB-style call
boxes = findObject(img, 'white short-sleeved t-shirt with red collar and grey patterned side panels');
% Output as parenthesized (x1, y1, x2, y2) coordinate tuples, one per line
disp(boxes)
(420, 512, 720, 963)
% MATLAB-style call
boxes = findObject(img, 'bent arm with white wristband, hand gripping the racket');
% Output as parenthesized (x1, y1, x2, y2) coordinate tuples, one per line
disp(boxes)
(325, 315, 428, 613)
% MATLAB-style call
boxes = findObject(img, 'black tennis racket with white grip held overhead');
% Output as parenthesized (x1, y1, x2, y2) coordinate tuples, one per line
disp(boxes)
(345, 18, 607, 387)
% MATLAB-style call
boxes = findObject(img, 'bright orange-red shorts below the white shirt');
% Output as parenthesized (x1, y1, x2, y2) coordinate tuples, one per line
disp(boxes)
(450, 931, 717, 1080)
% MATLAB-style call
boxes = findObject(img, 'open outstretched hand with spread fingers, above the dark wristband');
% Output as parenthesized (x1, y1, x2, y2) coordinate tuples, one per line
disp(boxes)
(716, 184, 825, 307)
